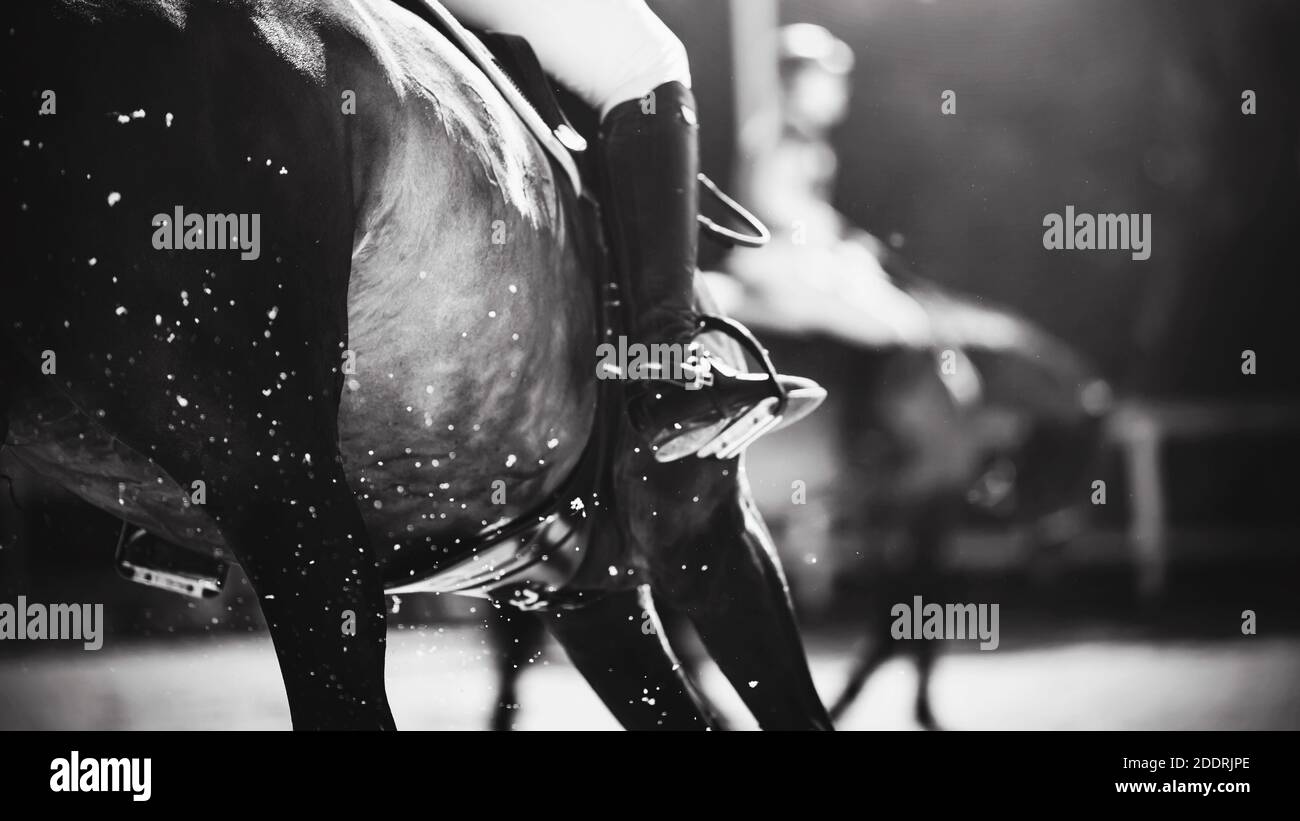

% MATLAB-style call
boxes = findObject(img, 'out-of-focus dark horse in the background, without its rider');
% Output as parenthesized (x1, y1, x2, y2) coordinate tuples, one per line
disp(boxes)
(712, 236, 1110, 727)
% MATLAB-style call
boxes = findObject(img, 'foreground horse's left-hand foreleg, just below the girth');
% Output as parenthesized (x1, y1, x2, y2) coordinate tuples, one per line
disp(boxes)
(546, 588, 710, 730)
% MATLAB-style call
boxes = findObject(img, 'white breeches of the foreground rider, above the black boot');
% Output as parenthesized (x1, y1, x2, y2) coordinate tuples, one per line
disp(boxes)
(443, 0, 690, 117)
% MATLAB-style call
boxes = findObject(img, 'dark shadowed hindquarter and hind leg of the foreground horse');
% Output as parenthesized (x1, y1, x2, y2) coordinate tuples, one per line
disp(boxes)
(0, 4, 393, 729)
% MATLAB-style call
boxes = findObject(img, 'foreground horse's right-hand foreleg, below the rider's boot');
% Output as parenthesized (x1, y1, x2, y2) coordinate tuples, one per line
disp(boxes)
(657, 491, 832, 730)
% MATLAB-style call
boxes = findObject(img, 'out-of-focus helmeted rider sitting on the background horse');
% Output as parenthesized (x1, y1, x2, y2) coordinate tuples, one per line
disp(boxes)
(725, 23, 939, 351)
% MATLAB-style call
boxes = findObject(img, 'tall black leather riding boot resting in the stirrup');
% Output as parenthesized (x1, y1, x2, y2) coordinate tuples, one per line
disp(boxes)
(601, 82, 826, 461)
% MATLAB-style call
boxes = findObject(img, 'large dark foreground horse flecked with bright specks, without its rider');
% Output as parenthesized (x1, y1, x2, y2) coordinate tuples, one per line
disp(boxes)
(0, 0, 831, 730)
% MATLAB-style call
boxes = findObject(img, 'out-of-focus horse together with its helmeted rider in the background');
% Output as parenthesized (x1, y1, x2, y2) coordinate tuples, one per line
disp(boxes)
(714, 23, 1109, 726)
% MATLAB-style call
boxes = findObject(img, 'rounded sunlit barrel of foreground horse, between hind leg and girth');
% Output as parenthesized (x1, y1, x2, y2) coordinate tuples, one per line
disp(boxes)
(339, 32, 595, 566)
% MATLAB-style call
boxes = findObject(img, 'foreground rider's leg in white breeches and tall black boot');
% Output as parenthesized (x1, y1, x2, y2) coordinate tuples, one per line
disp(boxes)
(445, 0, 826, 461)
